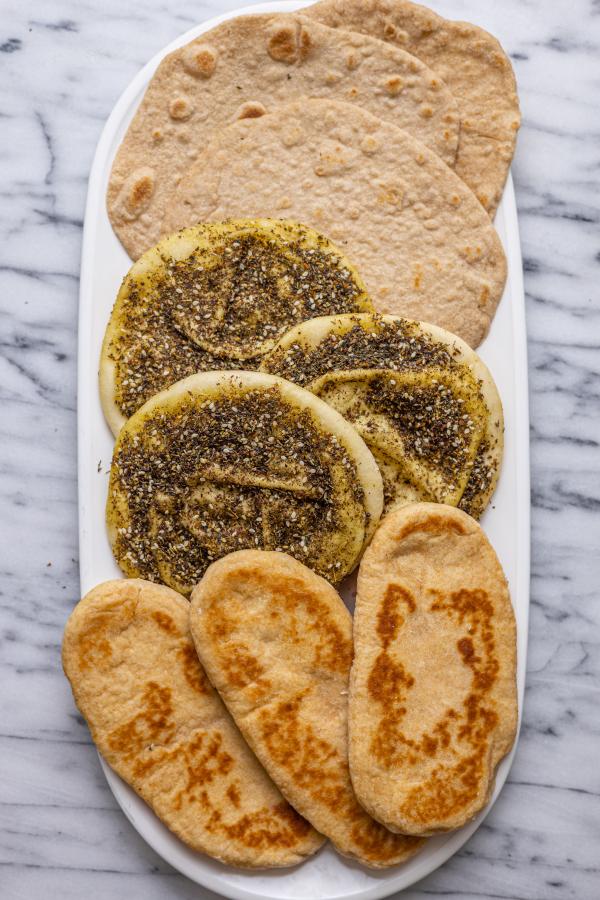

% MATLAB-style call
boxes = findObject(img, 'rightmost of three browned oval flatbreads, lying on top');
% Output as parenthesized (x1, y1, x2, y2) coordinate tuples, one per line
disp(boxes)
(349, 503, 517, 835)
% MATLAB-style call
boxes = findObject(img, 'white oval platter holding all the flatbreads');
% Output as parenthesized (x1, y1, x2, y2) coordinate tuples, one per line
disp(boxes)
(78, 2, 529, 900)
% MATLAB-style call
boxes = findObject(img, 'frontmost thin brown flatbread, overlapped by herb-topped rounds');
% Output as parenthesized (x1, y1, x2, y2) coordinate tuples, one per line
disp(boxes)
(162, 100, 506, 347)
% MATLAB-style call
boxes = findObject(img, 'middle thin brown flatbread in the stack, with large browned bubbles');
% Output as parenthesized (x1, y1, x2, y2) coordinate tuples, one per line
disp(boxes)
(107, 14, 459, 259)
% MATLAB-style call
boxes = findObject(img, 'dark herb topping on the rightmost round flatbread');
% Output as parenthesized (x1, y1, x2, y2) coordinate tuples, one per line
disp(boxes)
(263, 319, 497, 518)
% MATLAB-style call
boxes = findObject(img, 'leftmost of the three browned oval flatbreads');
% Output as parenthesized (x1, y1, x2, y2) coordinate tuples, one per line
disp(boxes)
(62, 580, 323, 868)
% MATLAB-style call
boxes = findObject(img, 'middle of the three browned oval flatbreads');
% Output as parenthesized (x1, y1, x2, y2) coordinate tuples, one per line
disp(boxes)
(190, 550, 421, 867)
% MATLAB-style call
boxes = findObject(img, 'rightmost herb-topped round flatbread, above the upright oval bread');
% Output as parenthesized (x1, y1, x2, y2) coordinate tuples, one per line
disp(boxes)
(261, 314, 503, 518)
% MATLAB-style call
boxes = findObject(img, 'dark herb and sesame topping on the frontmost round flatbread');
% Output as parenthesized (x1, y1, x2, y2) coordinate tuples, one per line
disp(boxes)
(109, 388, 364, 593)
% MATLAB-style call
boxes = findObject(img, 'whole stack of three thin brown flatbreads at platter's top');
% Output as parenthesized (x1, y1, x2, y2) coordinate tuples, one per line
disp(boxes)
(107, 0, 519, 347)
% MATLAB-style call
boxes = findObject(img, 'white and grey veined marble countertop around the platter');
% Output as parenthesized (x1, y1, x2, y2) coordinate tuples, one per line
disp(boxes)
(0, 0, 600, 900)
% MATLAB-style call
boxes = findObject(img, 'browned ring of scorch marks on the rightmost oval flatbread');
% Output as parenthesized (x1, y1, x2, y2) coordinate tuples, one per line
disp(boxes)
(368, 589, 500, 823)
